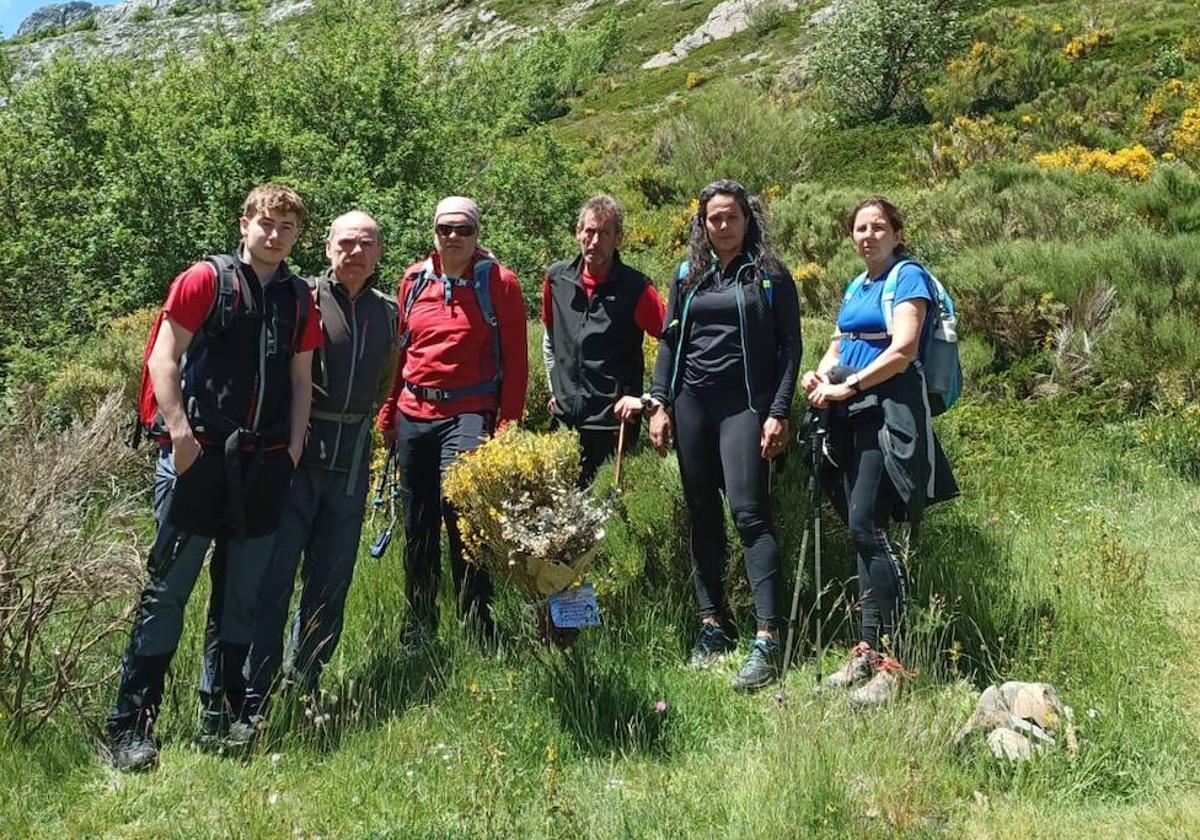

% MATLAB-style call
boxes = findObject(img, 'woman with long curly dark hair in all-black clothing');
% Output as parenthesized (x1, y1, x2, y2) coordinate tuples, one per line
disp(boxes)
(650, 181, 800, 690)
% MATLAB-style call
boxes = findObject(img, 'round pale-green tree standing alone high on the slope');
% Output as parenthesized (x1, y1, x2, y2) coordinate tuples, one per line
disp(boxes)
(811, 0, 966, 124)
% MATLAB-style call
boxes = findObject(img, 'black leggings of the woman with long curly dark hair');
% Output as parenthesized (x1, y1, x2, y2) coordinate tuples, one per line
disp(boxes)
(674, 386, 779, 630)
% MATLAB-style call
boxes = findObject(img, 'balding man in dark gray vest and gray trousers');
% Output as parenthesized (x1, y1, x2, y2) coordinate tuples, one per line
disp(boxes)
(205, 211, 400, 746)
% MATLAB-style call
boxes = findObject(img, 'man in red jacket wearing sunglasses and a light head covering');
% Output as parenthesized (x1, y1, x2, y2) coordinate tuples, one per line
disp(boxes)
(379, 196, 528, 646)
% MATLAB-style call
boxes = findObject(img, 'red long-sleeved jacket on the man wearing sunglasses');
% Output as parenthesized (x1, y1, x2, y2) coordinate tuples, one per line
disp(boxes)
(379, 253, 529, 430)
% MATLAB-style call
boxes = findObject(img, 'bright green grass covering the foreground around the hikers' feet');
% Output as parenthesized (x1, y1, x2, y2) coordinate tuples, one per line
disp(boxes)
(0, 401, 1200, 838)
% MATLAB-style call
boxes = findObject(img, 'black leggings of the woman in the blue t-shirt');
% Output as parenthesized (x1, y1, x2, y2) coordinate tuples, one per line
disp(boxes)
(822, 409, 906, 656)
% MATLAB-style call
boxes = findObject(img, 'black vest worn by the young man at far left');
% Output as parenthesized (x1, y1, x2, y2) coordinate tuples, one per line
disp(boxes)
(181, 253, 310, 445)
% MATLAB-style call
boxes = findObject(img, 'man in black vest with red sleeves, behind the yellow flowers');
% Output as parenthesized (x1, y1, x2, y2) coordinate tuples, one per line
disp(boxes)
(541, 196, 664, 486)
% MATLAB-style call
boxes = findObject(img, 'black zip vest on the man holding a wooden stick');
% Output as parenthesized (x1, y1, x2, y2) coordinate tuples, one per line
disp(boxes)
(546, 254, 650, 428)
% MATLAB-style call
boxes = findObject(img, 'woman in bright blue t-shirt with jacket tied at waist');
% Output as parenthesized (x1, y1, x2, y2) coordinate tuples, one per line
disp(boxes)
(800, 196, 958, 707)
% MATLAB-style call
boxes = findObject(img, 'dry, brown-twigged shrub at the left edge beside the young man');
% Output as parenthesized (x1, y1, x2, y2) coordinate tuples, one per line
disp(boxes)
(0, 394, 140, 737)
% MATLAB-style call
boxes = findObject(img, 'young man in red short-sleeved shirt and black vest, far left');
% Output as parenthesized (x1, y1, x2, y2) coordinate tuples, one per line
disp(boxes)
(108, 184, 322, 770)
